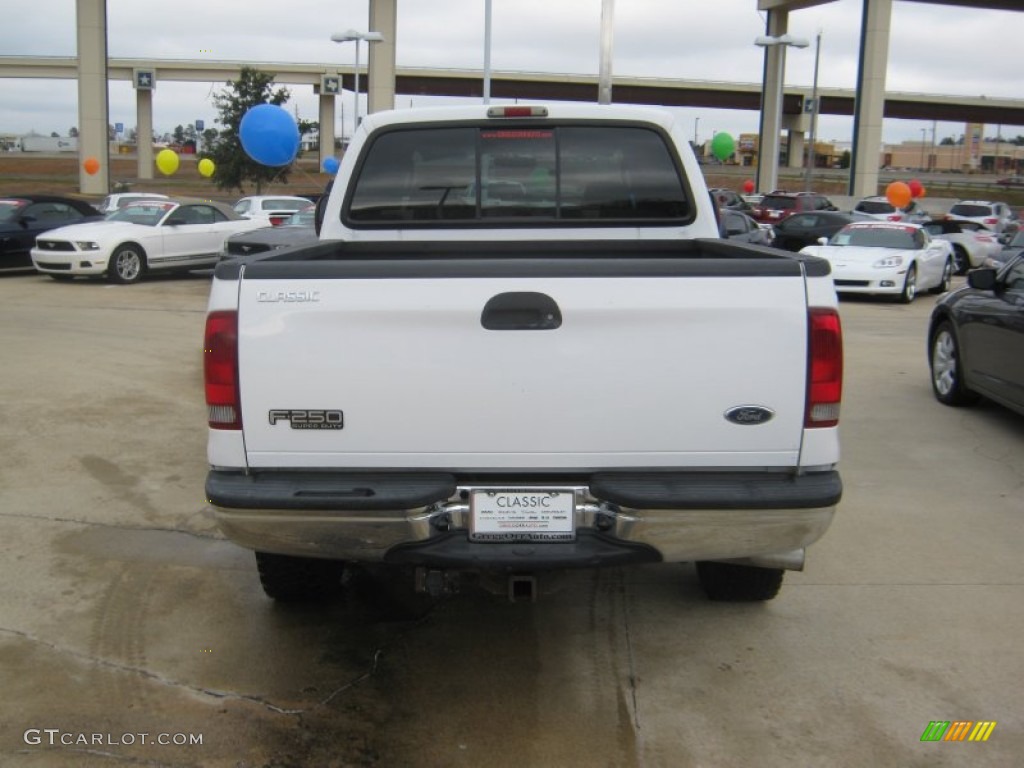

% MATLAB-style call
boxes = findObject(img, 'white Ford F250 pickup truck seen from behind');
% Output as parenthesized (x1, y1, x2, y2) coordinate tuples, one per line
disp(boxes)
(205, 104, 843, 600)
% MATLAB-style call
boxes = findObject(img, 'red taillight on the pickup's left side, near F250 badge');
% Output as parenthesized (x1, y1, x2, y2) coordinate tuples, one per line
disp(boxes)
(203, 311, 242, 429)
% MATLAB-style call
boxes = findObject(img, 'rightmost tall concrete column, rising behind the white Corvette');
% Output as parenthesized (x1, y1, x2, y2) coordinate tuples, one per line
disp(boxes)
(849, 0, 893, 198)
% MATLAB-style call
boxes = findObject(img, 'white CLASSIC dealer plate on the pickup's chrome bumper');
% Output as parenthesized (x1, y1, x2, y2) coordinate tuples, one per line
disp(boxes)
(469, 490, 575, 542)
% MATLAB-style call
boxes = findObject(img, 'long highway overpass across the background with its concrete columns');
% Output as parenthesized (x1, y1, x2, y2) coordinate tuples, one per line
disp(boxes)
(9, 0, 1024, 195)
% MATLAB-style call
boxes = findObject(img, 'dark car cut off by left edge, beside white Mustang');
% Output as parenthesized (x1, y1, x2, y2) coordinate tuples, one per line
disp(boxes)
(0, 195, 103, 269)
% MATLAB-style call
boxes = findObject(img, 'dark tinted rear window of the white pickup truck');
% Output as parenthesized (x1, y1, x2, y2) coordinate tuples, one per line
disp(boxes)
(346, 123, 691, 226)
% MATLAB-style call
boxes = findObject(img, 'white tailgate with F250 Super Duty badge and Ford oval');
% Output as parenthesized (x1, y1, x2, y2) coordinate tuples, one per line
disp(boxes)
(239, 259, 807, 471)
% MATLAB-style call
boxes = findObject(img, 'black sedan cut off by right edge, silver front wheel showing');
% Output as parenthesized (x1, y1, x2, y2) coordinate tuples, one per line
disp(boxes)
(928, 254, 1024, 415)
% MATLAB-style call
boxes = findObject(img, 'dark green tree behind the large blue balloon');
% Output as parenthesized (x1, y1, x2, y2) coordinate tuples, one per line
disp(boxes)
(203, 67, 291, 195)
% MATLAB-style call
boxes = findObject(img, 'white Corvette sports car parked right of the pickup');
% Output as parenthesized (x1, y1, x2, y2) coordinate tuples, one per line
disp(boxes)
(801, 221, 953, 304)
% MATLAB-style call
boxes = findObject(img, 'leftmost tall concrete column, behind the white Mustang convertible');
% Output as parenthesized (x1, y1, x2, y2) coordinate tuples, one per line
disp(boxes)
(75, 0, 111, 195)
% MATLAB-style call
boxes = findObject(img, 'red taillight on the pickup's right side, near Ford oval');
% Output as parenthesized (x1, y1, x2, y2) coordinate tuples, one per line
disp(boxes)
(804, 308, 843, 428)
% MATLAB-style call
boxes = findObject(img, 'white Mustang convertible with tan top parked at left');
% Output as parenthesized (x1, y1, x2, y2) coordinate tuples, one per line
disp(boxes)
(31, 199, 263, 283)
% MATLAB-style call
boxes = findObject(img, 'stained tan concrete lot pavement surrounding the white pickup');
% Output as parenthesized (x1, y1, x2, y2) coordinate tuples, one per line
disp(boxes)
(0, 274, 1024, 768)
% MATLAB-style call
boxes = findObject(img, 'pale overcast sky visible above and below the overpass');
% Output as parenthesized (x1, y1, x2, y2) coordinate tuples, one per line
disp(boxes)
(0, 0, 1024, 142)
